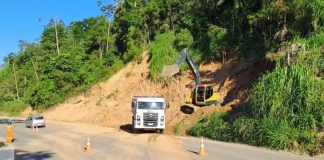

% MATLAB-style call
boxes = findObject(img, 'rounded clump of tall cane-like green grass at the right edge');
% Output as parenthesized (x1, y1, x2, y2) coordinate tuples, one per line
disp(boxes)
(247, 66, 324, 130)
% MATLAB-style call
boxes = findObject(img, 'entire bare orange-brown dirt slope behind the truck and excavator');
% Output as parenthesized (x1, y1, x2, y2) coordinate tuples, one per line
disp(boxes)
(44, 52, 267, 134)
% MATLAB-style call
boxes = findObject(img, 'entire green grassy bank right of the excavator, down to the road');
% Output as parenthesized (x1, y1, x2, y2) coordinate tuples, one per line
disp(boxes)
(187, 33, 324, 155)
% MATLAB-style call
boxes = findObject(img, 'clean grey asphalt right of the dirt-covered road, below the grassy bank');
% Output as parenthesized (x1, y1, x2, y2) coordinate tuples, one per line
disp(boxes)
(179, 137, 324, 160)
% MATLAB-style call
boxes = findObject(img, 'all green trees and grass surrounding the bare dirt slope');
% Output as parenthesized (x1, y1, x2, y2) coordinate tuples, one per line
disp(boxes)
(0, 0, 324, 152)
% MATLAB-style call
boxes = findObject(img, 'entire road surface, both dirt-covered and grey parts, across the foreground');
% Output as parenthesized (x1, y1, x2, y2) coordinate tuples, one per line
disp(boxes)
(0, 117, 324, 160)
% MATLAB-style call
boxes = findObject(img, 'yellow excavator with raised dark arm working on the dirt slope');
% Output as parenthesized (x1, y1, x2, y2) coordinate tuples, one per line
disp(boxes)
(162, 48, 219, 106)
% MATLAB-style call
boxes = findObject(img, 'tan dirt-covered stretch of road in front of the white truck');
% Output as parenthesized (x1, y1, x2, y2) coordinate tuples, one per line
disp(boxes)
(0, 118, 192, 160)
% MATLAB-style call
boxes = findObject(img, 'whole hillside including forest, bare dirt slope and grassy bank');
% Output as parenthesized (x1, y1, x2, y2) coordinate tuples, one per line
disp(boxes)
(0, 0, 324, 154)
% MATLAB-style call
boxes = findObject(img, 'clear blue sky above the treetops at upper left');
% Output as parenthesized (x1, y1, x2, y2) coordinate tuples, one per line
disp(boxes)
(0, 0, 112, 65)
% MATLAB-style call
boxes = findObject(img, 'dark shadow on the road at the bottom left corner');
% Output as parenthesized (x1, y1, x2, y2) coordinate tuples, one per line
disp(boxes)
(15, 149, 54, 160)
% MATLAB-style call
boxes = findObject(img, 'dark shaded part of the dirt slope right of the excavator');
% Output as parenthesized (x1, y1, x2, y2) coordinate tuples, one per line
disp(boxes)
(196, 59, 275, 106)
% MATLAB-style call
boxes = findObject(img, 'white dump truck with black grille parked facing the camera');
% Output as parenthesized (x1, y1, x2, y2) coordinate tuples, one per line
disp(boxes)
(132, 96, 166, 133)
